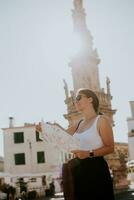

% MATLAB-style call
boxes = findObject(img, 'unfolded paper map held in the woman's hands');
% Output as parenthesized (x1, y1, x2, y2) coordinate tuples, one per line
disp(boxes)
(41, 121, 80, 152)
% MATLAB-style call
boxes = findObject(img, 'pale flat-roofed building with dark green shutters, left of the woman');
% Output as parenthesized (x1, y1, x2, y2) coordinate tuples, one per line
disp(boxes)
(3, 118, 65, 195)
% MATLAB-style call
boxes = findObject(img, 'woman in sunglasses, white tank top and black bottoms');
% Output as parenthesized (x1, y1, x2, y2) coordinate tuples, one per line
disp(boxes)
(65, 89, 114, 200)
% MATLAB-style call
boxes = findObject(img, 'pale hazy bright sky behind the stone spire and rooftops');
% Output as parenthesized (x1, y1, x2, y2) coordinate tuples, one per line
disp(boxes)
(0, 0, 134, 156)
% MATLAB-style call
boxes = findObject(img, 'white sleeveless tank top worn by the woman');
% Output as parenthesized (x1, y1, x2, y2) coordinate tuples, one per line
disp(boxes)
(73, 115, 104, 151)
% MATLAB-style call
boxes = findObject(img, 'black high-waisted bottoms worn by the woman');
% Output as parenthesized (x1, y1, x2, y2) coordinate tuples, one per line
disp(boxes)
(72, 157, 114, 200)
